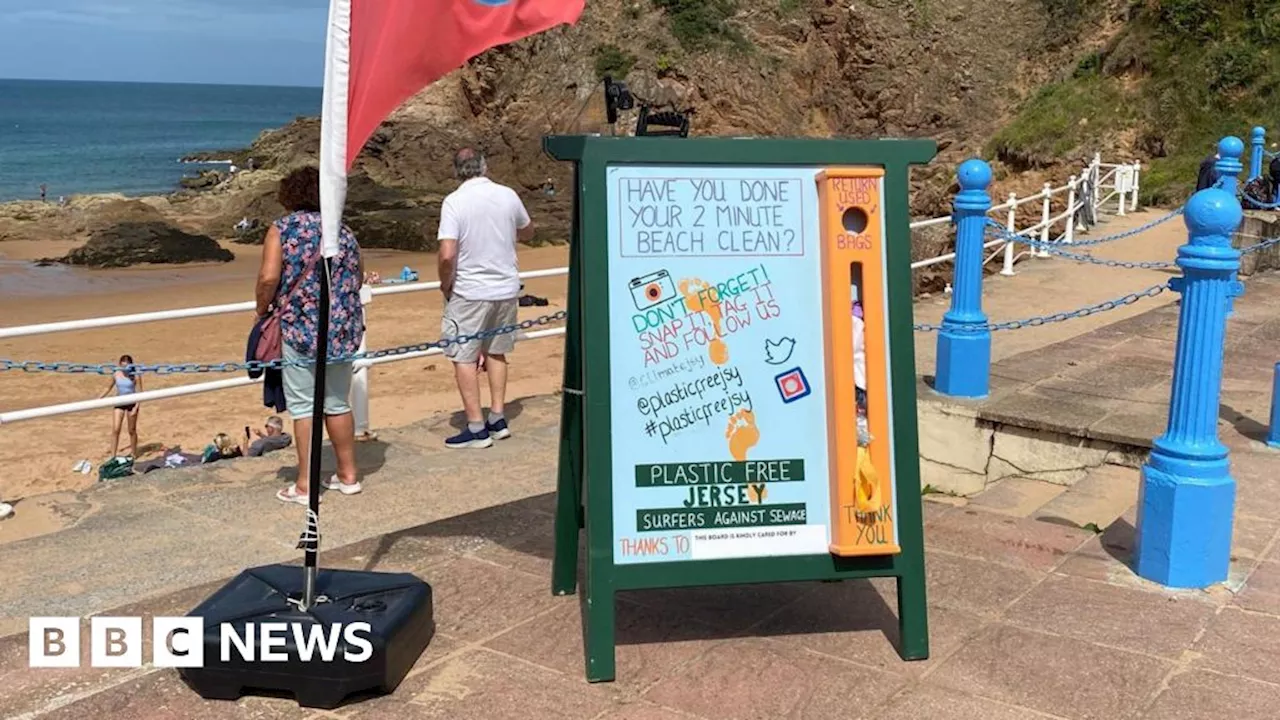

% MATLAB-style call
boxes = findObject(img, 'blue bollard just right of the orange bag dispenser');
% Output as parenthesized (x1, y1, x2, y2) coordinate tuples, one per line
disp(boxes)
(933, 159, 991, 397)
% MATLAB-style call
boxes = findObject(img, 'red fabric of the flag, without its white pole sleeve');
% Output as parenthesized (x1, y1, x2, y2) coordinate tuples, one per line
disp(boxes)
(347, 0, 585, 169)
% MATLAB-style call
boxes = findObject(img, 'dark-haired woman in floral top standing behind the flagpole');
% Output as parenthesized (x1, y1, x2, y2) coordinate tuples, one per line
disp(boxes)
(256, 167, 365, 505)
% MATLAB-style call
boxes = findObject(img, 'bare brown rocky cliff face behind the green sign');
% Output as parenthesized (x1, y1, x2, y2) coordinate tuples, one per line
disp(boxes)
(194, 0, 1075, 250)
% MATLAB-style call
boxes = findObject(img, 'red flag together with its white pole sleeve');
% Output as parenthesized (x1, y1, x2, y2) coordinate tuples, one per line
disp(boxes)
(320, 0, 585, 258)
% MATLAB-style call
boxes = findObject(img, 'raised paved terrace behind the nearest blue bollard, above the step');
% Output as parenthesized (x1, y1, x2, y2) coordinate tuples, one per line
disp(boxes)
(975, 272, 1280, 447)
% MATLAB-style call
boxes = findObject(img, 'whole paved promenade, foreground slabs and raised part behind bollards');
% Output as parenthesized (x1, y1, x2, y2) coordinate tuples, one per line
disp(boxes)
(0, 206, 1280, 720)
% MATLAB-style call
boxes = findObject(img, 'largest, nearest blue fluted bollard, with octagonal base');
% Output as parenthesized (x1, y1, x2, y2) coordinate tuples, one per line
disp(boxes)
(1134, 183, 1244, 588)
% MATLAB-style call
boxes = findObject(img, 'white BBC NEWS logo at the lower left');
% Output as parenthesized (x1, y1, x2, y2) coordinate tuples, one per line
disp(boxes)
(27, 618, 374, 667)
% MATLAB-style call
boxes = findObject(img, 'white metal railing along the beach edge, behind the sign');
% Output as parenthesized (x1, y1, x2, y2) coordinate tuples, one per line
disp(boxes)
(0, 154, 1140, 425)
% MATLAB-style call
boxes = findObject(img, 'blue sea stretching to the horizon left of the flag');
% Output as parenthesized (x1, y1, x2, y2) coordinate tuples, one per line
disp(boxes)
(0, 79, 320, 201)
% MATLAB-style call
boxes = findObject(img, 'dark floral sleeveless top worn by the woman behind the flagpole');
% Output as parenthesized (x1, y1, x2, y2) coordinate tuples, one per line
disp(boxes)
(275, 213, 365, 357)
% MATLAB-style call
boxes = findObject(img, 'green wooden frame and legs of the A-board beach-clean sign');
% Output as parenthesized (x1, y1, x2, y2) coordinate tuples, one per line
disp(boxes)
(543, 136, 937, 682)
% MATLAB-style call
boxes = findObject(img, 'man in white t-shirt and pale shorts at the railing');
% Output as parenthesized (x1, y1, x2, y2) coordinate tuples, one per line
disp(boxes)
(436, 147, 534, 447)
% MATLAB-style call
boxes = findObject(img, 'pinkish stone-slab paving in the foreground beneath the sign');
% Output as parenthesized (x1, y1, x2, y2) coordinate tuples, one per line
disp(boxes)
(0, 481, 1280, 720)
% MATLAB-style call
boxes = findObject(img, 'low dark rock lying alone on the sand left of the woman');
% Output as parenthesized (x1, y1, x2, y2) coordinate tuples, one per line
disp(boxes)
(60, 220, 236, 268)
